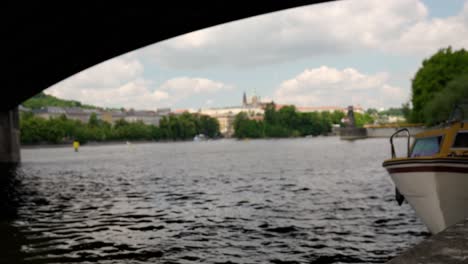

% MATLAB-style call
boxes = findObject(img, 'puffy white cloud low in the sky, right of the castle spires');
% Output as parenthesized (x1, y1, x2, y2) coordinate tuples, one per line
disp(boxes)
(273, 66, 408, 107)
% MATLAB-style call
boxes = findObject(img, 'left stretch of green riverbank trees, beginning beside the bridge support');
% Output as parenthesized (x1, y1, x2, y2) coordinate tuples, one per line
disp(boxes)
(20, 112, 219, 144)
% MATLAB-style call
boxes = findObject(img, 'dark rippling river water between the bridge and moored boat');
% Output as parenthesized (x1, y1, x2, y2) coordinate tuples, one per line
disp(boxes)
(0, 137, 429, 263)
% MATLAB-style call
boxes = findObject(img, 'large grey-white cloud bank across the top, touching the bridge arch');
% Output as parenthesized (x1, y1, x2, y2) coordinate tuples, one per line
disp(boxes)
(144, 0, 468, 68)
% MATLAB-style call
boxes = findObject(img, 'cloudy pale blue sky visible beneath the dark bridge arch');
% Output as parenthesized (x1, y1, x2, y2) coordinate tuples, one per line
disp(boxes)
(45, 0, 468, 110)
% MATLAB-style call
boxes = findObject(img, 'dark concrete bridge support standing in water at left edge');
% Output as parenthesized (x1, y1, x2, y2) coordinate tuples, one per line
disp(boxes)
(0, 107, 21, 164)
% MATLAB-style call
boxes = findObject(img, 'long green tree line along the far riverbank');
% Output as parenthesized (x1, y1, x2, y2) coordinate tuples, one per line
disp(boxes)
(20, 103, 372, 146)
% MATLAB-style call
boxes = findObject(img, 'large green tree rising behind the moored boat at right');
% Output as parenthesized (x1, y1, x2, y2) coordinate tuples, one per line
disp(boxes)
(410, 47, 468, 125)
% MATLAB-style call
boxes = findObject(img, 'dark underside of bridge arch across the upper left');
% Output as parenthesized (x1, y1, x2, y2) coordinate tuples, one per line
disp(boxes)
(0, 0, 330, 111)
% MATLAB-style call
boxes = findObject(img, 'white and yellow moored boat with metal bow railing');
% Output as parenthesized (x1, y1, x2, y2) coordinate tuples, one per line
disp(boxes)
(383, 103, 468, 234)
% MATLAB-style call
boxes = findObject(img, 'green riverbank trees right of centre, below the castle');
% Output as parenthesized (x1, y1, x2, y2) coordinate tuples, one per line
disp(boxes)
(234, 103, 373, 138)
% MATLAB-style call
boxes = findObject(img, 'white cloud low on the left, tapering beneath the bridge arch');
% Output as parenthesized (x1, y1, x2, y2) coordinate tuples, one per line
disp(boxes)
(45, 55, 232, 110)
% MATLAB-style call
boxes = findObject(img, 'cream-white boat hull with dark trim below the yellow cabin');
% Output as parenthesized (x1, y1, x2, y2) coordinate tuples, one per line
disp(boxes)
(383, 158, 468, 234)
